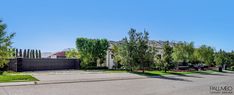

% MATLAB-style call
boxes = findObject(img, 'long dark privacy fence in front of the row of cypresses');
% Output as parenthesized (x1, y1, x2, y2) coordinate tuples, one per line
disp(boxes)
(8, 58, 80, 72)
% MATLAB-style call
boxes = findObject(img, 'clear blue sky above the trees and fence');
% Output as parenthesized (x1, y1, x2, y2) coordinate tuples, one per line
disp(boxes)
(0, 0, 234, 52)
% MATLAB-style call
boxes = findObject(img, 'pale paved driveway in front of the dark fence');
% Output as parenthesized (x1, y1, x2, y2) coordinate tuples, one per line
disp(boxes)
(24, 70, 146, 82)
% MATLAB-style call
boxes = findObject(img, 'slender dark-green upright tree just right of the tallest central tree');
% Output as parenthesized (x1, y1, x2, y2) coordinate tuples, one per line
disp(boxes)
(163, 41, 173, 72)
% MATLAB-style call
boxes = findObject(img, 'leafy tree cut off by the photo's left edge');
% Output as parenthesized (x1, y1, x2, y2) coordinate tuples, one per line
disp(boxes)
(0, 21, 15, 68)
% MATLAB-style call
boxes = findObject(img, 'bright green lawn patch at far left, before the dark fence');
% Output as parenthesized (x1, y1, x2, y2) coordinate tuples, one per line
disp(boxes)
(0, 72, 38, 83)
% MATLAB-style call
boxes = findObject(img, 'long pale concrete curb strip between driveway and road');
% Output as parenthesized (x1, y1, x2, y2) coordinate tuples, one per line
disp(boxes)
(0, 77, 149, 87)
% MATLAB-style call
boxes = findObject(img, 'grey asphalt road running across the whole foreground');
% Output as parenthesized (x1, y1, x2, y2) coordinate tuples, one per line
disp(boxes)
(0, 73, 234, 95)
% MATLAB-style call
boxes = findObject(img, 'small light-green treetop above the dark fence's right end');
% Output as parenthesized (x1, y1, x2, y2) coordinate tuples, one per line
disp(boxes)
(65, 48, 80, 58)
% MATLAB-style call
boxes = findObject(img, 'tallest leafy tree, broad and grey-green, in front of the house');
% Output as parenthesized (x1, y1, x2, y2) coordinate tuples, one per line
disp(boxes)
(111, 29, 156, 72)
